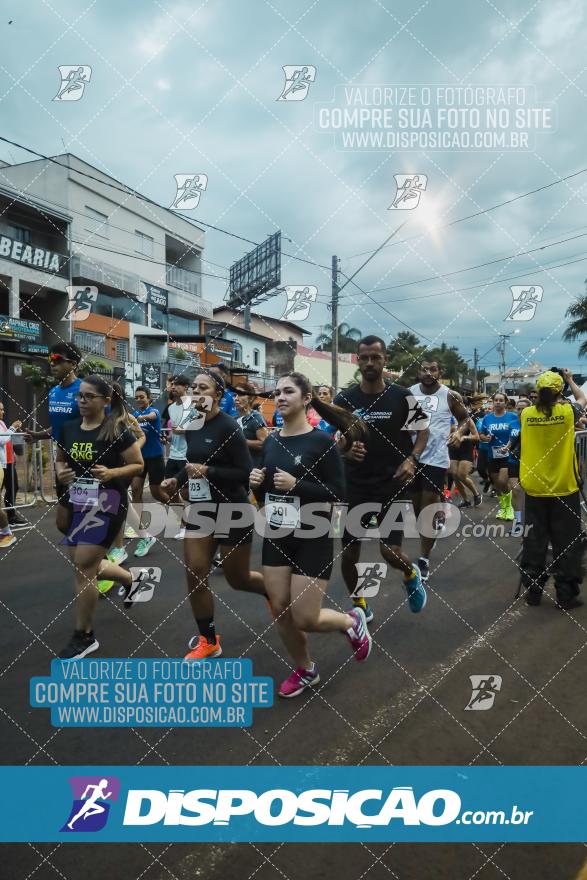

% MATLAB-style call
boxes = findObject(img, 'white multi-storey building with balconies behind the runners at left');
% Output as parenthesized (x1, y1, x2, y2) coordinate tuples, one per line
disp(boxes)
(0, 153, 212, 402)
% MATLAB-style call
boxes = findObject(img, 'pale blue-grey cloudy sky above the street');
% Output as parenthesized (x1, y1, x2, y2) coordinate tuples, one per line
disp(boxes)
(0, 0, 587, 372)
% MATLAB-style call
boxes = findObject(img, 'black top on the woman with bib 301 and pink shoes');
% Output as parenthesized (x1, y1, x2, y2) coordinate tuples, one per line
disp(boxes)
(255, 428, 346, 503)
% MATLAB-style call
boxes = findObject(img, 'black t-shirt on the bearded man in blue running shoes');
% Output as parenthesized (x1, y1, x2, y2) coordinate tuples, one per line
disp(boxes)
(334, 384, 414, 498)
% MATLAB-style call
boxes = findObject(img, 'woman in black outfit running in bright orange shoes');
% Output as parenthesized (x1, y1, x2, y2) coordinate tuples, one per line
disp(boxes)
(162, 372, 267, 660)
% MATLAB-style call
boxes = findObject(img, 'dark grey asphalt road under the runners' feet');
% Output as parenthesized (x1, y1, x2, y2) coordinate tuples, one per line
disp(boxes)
(0, 499, 587, 880)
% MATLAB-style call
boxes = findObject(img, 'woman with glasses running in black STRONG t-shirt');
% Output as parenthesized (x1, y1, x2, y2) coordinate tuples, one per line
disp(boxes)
(55, 376, 143, 660)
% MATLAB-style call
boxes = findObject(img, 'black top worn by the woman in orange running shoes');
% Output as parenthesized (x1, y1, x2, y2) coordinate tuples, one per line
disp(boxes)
(177, 412, 253, 504)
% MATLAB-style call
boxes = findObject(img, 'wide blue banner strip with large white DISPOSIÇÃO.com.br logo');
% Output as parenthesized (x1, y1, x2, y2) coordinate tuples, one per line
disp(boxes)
(0, 766, 587, 843)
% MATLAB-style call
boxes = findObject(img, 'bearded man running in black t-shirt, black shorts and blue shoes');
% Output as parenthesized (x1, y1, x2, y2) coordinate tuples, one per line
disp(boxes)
(334, 336, 428, 622)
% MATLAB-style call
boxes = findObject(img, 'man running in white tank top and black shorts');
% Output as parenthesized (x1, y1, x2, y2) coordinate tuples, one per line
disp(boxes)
(410, 361, 469, 580)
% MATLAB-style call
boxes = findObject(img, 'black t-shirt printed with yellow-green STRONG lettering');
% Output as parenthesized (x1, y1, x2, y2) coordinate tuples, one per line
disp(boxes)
(59, 418, 137, 498)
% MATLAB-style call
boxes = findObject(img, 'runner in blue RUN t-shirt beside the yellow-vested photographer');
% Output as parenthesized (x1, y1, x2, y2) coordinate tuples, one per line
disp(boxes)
(479, 391, 520, 522)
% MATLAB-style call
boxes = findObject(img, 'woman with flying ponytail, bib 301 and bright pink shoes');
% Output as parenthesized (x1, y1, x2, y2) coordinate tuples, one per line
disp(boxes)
(250, 372, 371, 697)
